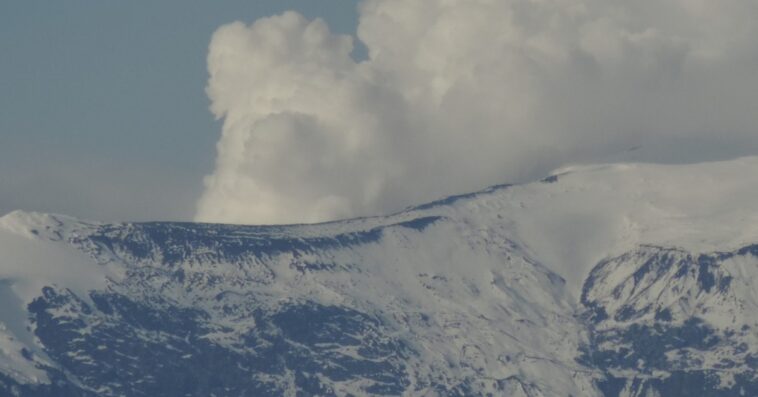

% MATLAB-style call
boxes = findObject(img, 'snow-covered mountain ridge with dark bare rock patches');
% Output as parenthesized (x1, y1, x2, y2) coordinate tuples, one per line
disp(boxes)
(0, 158, 758, 397)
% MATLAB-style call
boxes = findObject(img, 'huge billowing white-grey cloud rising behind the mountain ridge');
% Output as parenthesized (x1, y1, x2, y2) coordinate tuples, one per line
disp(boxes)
(196, 0, 758, 223)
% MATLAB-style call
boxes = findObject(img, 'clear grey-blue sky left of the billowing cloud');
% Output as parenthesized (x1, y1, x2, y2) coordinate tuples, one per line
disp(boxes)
(0, 0, 356, 220)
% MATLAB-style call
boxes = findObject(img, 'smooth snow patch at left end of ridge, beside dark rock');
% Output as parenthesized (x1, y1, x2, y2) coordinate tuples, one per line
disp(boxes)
(0, 211, 118, 383)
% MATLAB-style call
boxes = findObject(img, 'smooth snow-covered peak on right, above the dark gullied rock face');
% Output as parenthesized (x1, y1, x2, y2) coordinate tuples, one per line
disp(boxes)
(430, 157, 758, 296)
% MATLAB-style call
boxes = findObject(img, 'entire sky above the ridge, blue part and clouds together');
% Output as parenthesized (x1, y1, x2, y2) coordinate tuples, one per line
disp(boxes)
(0, 0, 758, 224)
